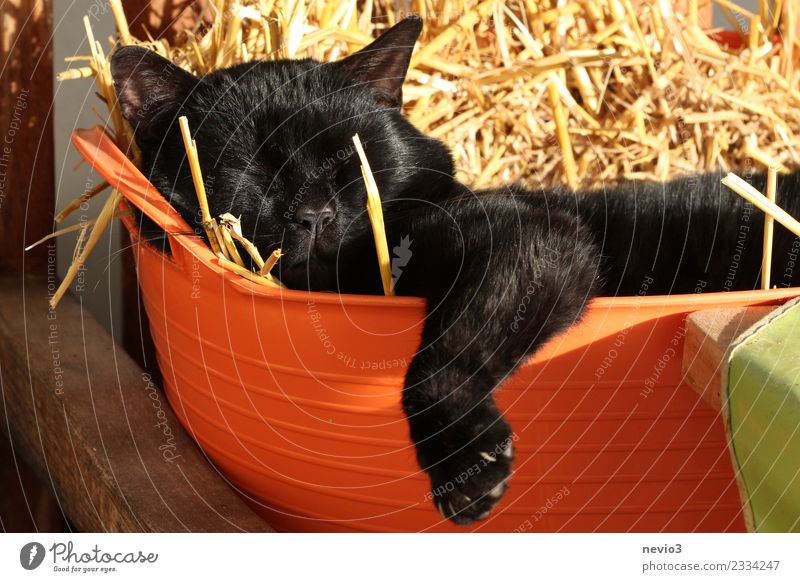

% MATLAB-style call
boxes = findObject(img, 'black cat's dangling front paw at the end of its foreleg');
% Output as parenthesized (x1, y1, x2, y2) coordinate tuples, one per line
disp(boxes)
(427, 423, 514, 525)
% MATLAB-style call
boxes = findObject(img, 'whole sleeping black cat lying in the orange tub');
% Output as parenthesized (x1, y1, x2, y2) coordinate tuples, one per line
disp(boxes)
(112, 18, 800, 524)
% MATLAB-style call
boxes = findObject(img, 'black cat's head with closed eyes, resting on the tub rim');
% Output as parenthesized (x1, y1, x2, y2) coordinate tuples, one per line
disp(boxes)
(111, 18, 453, 290)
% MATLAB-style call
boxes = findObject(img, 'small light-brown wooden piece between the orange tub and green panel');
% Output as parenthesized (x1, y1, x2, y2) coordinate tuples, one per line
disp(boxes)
(683, 306, 776, 411)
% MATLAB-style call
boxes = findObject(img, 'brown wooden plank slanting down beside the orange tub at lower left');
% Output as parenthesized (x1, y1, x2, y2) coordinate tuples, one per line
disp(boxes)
(0, 278, 270, 532)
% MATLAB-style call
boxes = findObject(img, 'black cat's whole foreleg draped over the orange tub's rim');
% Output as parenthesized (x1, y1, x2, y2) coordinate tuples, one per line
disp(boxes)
(388, 193, 598, 524)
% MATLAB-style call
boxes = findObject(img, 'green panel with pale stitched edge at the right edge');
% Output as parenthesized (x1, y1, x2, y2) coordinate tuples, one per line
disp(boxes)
(723, 302, 800, 532)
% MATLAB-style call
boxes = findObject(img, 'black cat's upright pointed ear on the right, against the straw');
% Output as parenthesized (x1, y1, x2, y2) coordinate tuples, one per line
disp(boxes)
(336, 16, 422, 107)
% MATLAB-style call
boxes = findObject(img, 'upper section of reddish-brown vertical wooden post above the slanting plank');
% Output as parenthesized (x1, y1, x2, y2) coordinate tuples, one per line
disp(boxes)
(0, 0, 55, 274)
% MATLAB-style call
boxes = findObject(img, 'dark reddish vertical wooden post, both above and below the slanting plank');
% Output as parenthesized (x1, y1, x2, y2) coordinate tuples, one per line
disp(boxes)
(0, 0, 63, 532)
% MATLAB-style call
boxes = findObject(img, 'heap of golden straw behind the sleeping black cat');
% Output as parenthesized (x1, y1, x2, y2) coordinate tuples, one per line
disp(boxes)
(62, 0, 800, 187)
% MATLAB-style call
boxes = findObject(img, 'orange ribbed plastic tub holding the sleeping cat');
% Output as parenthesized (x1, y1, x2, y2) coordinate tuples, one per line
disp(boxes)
(73, 128, 800, 532)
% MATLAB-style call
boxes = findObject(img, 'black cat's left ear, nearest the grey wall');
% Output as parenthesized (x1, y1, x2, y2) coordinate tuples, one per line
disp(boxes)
(111, 46, 199, 130)
